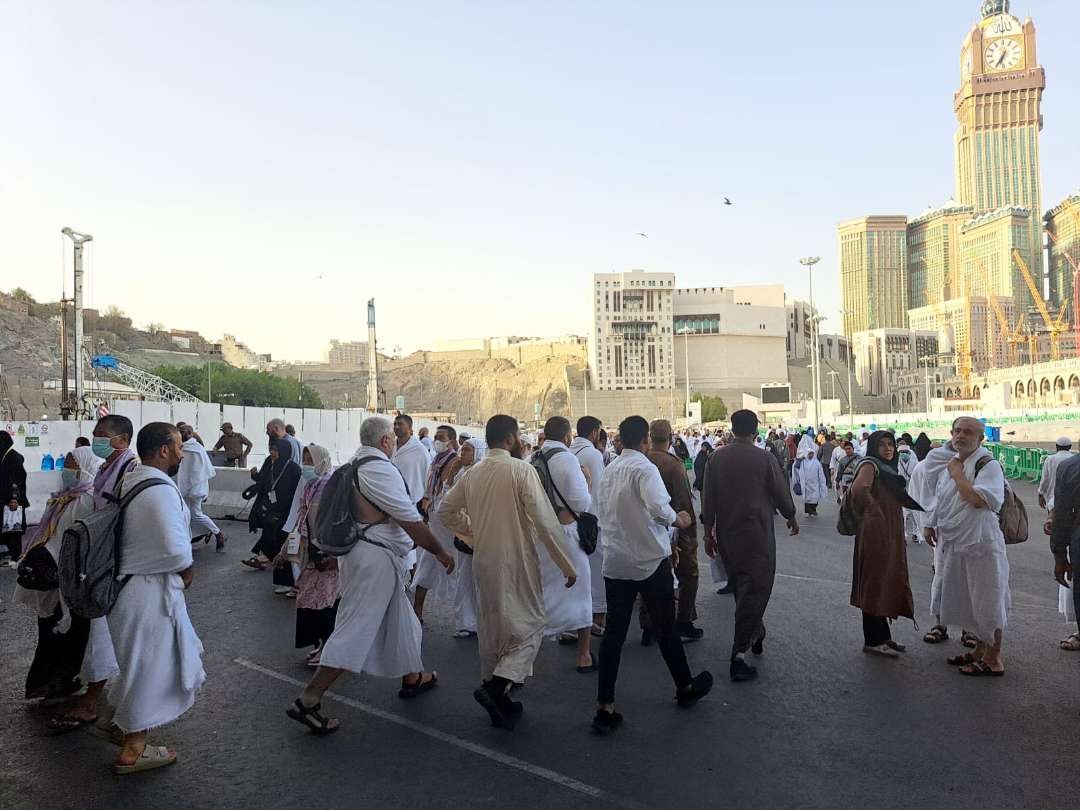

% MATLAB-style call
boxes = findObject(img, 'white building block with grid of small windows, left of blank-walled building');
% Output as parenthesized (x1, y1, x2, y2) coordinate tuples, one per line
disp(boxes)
(589, 270, 675, 391)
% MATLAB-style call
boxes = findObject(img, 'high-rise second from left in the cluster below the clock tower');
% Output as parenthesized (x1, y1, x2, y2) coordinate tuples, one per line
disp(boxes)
(907, 201, 974, 309)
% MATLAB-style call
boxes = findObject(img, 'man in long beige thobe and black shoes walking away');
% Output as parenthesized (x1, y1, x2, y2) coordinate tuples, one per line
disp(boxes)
(438, 415, 576, 729)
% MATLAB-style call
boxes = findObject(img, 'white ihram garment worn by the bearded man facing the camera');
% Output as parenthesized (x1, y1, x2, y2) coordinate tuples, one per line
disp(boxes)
(927, 447, 1012, 642)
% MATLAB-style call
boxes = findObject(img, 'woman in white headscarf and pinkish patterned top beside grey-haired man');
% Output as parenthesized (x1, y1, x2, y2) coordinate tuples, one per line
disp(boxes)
(276, 444, 338, 666)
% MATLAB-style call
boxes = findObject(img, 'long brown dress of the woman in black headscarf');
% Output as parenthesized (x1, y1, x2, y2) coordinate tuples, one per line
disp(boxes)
(851, 462, 915, 619)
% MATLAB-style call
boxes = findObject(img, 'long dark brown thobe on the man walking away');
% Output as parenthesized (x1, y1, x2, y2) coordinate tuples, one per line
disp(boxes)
(701, 442, 795, 652)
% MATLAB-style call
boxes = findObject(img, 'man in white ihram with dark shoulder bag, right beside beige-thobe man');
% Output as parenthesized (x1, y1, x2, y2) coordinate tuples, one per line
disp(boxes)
(532, 416, 596, 673)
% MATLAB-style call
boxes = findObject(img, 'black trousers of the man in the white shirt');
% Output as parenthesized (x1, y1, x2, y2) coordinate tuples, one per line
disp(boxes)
(596, 559, 692, 703)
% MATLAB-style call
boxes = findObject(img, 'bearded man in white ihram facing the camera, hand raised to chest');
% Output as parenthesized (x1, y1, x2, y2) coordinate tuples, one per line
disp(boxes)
(923, 417, 1012, 676)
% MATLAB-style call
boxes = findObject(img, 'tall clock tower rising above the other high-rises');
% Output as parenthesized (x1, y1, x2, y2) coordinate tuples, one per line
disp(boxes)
(954, 0, 1047, 291)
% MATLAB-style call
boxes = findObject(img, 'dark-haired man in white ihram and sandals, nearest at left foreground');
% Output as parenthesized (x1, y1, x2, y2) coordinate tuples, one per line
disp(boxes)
(108, 422, 206, 774)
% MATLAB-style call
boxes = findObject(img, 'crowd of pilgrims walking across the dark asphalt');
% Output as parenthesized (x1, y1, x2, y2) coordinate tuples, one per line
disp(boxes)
(0, 410, 1080, 773)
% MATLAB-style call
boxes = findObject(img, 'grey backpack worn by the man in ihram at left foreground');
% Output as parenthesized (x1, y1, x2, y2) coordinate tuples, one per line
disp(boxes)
(59, 478, 170, 619)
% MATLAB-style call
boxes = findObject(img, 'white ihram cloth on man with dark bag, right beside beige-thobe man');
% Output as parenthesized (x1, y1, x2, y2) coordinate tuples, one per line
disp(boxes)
(537, 438, 593, 635)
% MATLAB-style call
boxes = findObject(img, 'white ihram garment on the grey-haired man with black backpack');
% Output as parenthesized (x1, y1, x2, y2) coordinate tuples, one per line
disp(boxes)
(321, 442, 428, 678)
